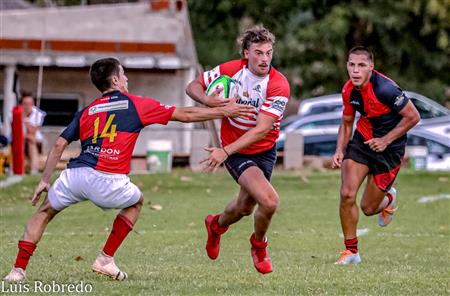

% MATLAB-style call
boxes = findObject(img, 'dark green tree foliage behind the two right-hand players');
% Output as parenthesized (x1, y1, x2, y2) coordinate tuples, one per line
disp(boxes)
(189, 0, 450, 103)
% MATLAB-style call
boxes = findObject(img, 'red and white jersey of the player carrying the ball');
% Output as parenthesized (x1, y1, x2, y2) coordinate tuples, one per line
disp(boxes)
(201, 59, 290, 154)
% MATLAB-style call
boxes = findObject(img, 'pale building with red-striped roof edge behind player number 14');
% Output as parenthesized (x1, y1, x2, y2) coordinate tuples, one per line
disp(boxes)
(0, 1, 197, 162)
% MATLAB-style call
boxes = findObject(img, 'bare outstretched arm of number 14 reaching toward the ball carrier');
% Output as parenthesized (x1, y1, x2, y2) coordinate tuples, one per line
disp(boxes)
(170, 98, 256, 122)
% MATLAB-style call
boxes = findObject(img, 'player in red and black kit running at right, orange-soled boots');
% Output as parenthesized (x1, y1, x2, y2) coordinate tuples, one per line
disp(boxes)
(333, 46, 420, 265)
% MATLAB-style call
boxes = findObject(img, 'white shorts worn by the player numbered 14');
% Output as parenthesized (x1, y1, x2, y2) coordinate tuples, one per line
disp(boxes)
(47, 167, 141, 211)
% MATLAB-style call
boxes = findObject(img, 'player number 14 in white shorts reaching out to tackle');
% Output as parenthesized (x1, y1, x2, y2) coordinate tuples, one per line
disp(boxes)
(4, 58, 255, 282)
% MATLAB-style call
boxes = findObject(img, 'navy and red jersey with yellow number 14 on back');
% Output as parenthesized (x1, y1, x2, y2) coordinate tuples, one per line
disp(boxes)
(61, 90, 175, 174)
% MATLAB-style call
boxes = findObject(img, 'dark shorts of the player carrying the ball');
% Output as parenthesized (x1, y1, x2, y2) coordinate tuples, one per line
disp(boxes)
(225, 145, 277, 182)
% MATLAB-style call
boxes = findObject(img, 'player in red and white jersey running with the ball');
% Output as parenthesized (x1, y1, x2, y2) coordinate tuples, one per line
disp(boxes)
(186, 26, 290, 274)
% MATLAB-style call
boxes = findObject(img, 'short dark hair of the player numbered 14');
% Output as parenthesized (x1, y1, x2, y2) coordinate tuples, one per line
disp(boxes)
(89, 58, 120, 92)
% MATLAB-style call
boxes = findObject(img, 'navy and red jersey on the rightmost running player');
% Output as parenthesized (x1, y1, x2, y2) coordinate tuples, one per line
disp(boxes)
(342, 71, 409, 149)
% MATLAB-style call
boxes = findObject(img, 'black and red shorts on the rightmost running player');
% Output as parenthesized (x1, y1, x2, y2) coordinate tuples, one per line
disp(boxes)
(344, 132, 405, 192)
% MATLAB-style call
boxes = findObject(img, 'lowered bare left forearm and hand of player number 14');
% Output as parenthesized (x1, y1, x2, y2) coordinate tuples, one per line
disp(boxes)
(31, 137, 69, 206)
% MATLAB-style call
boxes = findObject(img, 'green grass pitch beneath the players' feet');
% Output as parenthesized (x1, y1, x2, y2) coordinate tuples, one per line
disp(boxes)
(0, 170, 450, 295)
